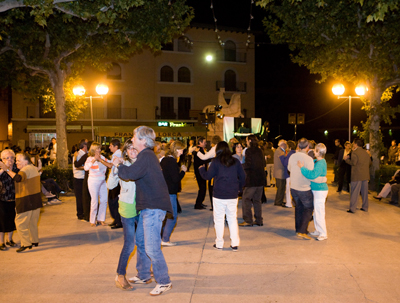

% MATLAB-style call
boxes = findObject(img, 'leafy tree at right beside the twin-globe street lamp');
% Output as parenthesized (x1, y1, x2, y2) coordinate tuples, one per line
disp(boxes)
(258, 0, 400, 173)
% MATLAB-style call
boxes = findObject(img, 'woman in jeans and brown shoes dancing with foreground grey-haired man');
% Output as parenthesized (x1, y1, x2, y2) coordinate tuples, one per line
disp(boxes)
(107, 140, 139, 290)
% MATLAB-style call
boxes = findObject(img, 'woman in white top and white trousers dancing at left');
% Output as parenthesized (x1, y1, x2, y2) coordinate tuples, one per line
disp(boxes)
(84, 142, 112, 227)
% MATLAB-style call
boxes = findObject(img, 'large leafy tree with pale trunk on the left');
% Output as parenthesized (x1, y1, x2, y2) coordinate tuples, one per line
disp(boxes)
(0, 0, 193, 168)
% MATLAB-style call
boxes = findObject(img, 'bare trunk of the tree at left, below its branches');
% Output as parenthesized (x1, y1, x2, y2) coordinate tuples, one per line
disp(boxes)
(50, 69, 68, 168)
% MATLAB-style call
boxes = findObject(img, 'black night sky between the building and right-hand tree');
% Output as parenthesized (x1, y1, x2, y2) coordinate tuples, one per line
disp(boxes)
(187, 0, 400, 149)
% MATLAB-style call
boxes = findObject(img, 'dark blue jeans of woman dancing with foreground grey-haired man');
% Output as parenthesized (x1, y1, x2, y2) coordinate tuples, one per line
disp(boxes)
(117, 216, 139, 276)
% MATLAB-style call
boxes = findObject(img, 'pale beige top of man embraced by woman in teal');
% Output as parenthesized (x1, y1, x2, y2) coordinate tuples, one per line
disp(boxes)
(288, 151, 314, 191)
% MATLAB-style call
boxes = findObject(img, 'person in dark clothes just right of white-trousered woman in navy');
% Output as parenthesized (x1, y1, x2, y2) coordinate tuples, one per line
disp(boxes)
(239, 135, 266, 226)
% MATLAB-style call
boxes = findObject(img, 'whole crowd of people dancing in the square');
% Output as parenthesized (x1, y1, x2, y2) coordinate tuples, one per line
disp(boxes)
(0, 126, 378, 296)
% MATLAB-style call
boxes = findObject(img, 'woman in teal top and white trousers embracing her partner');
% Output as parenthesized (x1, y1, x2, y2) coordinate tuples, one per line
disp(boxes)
(297, 143, 328, 241)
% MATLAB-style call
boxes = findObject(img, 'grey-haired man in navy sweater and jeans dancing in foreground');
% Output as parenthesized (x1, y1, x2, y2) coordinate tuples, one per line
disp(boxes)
(113, 126, 172, 296)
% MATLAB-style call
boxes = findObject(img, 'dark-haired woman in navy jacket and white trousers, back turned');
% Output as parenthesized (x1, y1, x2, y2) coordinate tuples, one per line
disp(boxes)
(199, 141, 246, 251)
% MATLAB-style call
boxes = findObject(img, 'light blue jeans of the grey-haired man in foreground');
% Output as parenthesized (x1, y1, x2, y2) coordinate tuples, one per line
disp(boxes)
(136, 208, 171, 284)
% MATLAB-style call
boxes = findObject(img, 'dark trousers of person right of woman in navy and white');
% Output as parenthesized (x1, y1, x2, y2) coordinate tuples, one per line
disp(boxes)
(242, 186, 264, 224)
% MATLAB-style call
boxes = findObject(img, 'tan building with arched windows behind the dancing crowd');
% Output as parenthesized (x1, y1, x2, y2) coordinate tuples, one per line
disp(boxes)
(8, 26, 255, 149)
